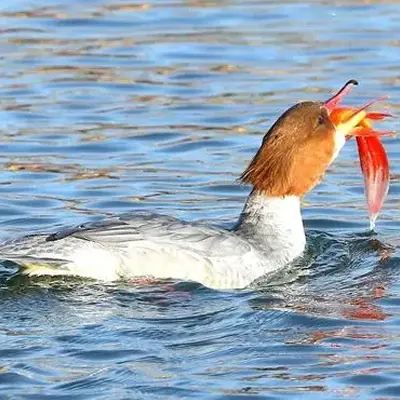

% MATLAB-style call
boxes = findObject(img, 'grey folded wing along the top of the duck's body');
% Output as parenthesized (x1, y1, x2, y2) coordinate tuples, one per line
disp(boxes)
(46, 212, 250, 255)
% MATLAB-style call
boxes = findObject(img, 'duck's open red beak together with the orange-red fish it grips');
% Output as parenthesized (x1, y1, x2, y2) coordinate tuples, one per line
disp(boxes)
(324, 79, 393, 230)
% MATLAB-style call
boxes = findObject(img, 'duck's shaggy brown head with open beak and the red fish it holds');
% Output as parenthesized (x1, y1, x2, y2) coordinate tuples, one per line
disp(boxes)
(241, 80, 389, 227)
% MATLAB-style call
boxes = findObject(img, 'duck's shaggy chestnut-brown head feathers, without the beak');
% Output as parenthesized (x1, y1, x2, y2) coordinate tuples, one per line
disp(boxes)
(241, 102, 336, 197)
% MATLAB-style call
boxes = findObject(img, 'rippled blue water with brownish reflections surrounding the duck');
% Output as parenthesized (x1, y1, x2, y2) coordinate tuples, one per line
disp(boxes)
(0, 0, 400, 400)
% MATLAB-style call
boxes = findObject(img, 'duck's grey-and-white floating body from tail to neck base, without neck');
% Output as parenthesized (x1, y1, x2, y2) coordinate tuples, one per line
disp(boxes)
(0, 213, 265, 288)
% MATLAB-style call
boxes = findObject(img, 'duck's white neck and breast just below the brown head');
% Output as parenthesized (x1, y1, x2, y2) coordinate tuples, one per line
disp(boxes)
(236, 193, 306, 266)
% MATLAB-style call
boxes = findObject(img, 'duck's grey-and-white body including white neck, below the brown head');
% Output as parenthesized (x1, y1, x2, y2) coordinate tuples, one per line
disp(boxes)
(0, 195, 305, 289)
